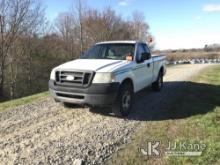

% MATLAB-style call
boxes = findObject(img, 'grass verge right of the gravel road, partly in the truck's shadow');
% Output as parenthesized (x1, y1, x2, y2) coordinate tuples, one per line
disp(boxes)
(106, 65, 220, 165)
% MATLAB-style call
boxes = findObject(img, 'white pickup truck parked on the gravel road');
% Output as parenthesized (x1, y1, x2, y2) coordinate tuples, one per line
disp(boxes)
(49, 41, 166, 116)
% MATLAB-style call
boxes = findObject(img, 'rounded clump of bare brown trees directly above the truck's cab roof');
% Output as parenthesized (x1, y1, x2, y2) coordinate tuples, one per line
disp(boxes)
(83, 7, 138, 45)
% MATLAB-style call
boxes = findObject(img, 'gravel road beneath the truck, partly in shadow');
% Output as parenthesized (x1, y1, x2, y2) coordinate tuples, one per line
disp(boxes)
(0, 64, 213, 164)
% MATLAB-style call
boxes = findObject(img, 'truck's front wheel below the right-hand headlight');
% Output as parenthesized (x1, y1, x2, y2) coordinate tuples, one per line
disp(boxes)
(112, 83, 134, 117)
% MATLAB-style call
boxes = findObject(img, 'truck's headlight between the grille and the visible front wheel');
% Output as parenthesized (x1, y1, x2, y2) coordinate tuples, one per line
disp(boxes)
(92, 73, 115, 83)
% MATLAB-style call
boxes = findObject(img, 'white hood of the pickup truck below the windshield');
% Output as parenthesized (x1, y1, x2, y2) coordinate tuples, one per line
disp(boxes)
(56, 59, 128, 72)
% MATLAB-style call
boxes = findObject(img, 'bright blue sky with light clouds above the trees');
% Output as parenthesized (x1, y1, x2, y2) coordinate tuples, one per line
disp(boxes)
(42, 0, 220, 49)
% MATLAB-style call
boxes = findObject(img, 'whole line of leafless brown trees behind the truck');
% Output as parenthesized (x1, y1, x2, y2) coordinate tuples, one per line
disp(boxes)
(0, 0, 150, 101)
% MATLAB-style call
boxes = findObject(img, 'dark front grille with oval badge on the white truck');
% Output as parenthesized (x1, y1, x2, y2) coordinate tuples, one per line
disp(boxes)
(56, 71, 94, 86)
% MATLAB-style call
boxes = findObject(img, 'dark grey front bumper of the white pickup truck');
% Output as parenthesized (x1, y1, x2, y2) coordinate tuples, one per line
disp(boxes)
(49, 80, 119, 106)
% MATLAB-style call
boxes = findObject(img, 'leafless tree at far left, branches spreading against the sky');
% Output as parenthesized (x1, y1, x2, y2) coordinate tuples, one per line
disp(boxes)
(0, 0, 44, 97)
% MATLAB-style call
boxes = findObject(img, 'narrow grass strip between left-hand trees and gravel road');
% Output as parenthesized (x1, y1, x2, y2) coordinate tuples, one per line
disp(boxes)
(0, 92, 48, 111)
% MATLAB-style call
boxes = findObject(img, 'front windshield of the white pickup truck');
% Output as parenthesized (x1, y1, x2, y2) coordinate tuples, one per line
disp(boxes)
(80, 44, 135, 60)
